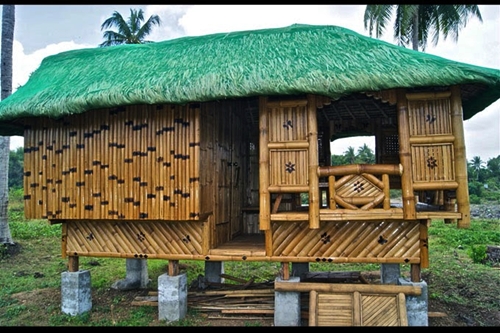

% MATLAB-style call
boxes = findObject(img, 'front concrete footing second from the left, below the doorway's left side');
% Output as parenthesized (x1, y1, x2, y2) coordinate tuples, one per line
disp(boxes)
(158, 273, 188, 321)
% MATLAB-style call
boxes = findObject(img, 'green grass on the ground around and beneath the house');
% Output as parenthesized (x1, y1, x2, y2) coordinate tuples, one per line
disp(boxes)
(0, 187, 500, 326)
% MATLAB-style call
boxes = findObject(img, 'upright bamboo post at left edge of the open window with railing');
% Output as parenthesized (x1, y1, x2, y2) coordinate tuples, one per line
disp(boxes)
(307, 95, 321, 229)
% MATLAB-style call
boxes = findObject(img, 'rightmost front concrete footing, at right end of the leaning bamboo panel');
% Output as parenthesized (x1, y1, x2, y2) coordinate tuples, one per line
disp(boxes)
(398, 278, 429, 326)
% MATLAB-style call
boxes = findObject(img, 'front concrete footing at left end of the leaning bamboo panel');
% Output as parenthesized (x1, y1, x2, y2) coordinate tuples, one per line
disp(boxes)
(274, 276, 302, 326)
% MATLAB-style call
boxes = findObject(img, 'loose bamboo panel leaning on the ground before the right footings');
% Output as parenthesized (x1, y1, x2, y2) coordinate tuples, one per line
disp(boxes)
(309, 290, 408, 326)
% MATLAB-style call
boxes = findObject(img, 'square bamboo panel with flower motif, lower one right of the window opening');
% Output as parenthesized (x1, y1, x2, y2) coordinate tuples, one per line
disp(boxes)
(411, 144, 455, 182)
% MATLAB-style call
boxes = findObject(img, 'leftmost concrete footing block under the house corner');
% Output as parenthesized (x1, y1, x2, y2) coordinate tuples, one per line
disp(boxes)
(61, 270, 92, 316)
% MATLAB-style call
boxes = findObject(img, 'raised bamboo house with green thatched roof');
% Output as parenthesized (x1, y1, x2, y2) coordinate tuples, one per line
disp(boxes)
(0, 24, 500, 298)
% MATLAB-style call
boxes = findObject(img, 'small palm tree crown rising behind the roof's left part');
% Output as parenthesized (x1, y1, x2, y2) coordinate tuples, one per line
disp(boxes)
(99, 8, 161, 47)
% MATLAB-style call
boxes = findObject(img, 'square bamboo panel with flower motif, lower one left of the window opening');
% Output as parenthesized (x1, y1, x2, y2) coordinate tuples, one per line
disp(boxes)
(269, 150, 309, 187)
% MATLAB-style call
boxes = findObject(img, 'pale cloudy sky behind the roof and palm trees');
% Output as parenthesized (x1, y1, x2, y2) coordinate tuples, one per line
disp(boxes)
(0, 4, 500, 162)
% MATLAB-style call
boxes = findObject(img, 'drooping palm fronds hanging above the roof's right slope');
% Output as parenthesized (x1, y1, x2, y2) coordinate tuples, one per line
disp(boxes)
(364, 5, 483, 51)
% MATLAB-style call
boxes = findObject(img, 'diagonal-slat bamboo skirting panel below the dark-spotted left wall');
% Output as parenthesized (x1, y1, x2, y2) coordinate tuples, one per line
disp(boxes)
(65, 220, 202, 258)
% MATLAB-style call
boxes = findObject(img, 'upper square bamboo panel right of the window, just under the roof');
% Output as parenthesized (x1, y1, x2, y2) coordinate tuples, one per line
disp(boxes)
(408, 98, 453, 136)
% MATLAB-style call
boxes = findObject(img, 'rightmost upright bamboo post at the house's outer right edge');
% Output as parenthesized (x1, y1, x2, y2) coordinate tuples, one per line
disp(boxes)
(451, 86, 470, 228)
